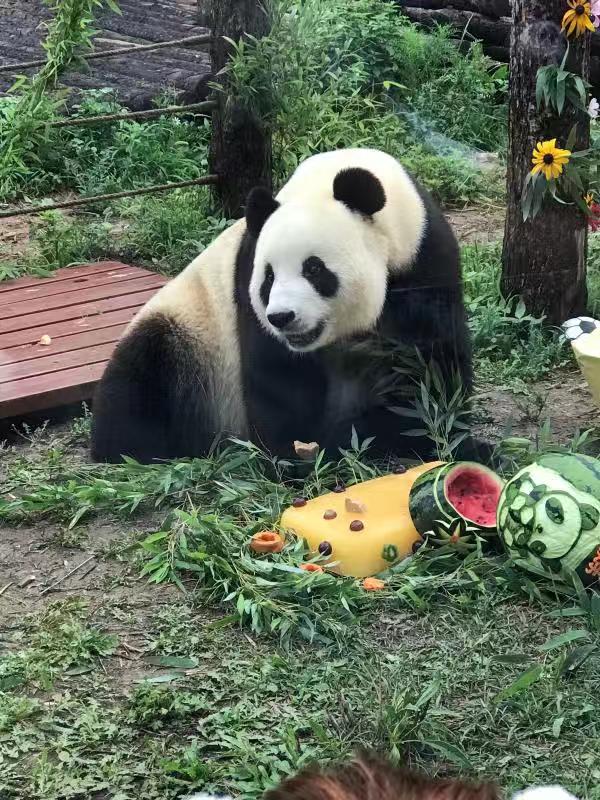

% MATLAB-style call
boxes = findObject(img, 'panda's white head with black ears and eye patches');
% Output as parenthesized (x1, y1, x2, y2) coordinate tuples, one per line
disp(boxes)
(246, 168, 388, 352)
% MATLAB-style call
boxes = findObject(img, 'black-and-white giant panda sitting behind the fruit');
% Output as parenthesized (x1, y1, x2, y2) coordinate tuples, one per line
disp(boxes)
(92, 148, 472, 463)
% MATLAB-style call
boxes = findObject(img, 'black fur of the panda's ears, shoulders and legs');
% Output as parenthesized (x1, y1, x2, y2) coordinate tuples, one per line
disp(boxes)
(92, 152, 476, 463)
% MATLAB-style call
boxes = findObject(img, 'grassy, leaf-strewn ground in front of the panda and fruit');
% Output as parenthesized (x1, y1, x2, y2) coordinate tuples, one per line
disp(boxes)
(0, 422, 600, 800)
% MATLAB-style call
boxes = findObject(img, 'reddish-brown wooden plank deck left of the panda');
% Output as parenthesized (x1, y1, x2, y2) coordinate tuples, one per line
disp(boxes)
(0, 261, 167, 419)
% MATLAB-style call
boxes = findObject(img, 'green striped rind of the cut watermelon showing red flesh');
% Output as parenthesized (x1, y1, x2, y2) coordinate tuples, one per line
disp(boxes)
(409, 461, 504, 536)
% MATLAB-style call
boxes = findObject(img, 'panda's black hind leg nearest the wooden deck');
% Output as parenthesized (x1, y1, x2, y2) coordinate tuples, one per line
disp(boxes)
(92, 315, 212, 463)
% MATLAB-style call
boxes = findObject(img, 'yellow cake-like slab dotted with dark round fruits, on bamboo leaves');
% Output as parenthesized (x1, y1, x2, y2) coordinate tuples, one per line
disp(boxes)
(281, 462, 440, 578)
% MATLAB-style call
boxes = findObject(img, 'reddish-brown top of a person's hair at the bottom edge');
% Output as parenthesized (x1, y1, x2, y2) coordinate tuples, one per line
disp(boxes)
(264, 755, 501, 800)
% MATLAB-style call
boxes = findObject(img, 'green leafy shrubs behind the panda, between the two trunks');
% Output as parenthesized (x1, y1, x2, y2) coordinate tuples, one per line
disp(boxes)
(229, 0, 505, 195)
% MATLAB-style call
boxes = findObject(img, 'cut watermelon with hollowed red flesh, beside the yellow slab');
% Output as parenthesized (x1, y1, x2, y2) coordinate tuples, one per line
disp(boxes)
(408, 461, 504, 536)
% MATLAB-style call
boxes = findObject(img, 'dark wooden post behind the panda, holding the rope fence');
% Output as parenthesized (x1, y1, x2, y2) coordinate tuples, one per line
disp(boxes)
(207, 0, 273, 219)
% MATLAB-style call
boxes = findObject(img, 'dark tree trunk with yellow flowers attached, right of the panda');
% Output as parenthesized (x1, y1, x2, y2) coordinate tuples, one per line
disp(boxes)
(502, 0, 590, 324)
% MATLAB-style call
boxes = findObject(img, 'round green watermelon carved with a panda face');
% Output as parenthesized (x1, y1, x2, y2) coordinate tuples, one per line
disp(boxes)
(498, 453, 600, 583)
